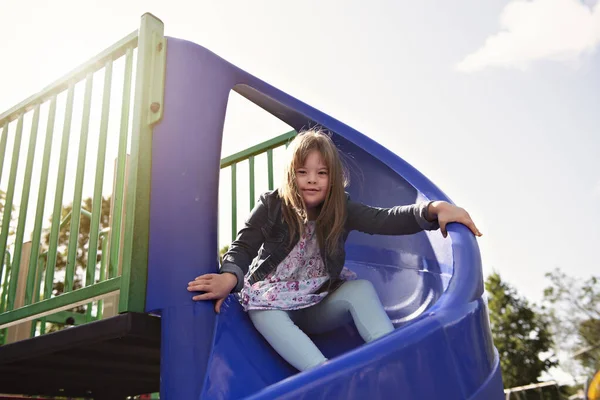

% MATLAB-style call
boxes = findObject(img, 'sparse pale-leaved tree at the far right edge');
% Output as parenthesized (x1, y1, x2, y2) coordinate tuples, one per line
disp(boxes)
(544, 268, 600, 376)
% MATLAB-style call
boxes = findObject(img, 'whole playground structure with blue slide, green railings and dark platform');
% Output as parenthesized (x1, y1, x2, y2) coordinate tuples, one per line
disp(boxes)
(0, 14, 504, 400)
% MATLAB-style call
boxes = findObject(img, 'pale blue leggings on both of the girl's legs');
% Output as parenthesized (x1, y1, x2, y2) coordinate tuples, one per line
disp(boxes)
(248, 280, 394, 371)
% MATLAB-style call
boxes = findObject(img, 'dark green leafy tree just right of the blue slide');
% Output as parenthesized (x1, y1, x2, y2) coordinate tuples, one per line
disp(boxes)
(485, 273, 558, 388)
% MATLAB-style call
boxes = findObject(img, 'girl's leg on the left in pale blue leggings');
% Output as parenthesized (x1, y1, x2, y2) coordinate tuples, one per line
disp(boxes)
(248, 310, 327, 371)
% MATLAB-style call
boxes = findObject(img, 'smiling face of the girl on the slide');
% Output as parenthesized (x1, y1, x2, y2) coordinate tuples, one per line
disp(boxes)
(295, 150, 329, 212)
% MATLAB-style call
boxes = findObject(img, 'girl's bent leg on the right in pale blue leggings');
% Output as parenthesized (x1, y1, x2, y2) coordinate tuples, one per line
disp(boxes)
(293, 279, 394, 342)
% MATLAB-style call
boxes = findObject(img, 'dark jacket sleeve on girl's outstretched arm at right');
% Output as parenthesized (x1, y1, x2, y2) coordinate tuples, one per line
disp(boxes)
(346, 200, 440, 235)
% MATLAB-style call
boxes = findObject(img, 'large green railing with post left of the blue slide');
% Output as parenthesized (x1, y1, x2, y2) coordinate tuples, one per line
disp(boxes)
(0, 14, 166, 342)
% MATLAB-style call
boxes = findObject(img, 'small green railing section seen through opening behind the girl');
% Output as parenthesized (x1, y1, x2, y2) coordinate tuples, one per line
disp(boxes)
(221, 131, 298, 240)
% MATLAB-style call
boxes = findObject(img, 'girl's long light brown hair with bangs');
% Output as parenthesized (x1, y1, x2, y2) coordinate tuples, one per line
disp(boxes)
(279, 128, 349, 254)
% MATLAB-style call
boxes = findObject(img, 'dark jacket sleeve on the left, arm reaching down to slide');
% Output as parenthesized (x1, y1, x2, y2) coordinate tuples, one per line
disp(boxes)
(220, 194, 268, 292)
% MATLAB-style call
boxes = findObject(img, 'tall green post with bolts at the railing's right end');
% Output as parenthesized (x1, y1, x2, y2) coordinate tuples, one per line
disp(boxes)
(119, 13, 167, 312)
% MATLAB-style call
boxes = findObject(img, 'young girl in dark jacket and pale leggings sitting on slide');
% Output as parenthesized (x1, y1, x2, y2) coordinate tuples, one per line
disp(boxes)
(188, 129, 481, 371)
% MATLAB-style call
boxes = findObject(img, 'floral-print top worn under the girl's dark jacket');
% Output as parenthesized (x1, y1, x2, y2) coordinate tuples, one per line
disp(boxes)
(240, 221, 356, 311)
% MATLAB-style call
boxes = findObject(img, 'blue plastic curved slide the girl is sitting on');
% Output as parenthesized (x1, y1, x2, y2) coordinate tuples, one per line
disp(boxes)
(146, 38, 503, 399)
